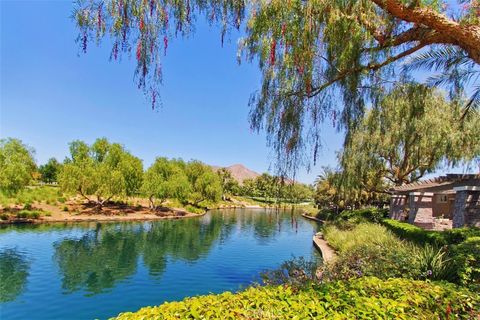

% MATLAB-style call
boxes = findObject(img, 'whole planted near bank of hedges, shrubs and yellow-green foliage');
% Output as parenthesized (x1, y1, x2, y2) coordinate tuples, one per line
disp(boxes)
(110, 208, 480, 319)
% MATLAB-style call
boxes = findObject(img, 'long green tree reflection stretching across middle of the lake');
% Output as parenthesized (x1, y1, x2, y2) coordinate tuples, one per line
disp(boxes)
(50, 210, 298, 295)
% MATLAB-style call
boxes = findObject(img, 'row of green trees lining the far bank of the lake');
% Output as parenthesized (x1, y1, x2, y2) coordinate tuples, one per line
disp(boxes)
(0, 138, 312, 209)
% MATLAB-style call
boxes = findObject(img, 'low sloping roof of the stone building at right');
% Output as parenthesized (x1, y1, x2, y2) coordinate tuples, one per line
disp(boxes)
(391, 174, 480, 192)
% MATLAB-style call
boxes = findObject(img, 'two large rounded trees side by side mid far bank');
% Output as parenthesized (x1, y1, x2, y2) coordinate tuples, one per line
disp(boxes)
(58, 138, 222, 209)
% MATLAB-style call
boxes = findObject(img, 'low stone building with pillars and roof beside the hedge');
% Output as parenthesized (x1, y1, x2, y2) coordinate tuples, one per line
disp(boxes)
(390, 174, 480, 230)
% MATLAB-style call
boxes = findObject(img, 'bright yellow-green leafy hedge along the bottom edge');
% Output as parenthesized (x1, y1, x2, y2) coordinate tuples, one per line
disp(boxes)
(113, 278, 480, 320)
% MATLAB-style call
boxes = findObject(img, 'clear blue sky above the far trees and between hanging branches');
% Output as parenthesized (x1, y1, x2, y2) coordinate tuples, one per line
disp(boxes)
(0, 0, 343, 183)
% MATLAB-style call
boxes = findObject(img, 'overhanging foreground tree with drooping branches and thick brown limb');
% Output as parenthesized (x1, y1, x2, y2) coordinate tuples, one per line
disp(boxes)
(74, 0, 480, 170)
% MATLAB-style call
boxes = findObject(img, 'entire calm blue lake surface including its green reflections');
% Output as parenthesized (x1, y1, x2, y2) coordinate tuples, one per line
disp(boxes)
(0, 210, 317, 320)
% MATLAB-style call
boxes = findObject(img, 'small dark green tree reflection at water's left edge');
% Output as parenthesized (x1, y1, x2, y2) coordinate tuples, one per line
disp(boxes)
(0, 248, 30, 302)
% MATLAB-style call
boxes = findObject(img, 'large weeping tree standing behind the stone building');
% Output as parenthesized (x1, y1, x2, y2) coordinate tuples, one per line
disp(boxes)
(341, 83, 480, 188)
